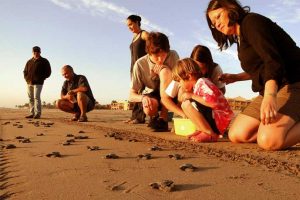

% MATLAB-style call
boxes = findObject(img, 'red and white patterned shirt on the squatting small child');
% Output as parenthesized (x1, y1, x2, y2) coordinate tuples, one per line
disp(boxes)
(194, 78, 234, 135)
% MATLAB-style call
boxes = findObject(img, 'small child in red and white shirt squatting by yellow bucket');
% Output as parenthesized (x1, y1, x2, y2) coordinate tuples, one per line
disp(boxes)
(173, 58, 233, 142)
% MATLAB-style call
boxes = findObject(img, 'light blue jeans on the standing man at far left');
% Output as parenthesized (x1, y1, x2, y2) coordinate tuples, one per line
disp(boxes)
(27, 85, 43, 116)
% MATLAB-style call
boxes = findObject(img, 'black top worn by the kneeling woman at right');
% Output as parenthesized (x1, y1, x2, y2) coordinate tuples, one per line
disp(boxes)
(238, 13, 300, 94)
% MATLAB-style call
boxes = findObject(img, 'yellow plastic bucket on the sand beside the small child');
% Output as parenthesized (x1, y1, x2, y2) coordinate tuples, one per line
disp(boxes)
(173, 118, 196, 136)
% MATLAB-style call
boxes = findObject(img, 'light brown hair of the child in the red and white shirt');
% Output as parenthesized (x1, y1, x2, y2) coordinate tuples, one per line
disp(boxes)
(172, 58, 203, 81)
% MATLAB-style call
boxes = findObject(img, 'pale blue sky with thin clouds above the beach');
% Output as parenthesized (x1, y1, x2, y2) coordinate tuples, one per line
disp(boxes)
(0, 0, 300, 107)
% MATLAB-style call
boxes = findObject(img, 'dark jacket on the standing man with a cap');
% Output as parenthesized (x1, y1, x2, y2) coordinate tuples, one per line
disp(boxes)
(24, 57, 51, 85)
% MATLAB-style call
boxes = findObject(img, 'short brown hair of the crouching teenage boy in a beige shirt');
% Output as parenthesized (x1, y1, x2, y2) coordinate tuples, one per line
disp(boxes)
(146, 32, 170, 55)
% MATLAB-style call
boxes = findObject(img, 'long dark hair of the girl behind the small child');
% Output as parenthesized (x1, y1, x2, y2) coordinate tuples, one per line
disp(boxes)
(190, 45, 217, 78)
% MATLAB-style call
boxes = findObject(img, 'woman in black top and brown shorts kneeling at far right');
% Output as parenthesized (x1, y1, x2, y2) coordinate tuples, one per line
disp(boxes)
(206, 0, 300, 150)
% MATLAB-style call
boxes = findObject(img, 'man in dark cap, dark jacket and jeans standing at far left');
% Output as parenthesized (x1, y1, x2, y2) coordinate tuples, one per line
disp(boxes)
(24, 46, 51, 119)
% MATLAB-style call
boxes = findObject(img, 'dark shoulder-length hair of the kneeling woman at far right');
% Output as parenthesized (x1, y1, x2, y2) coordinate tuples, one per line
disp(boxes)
(206, 0, 250, 50)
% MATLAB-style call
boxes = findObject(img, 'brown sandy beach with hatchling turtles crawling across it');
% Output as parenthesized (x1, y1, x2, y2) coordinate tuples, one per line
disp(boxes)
(0, 108, 300, 200)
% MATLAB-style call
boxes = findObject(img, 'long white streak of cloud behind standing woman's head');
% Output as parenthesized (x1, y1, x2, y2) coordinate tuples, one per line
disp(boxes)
(50, 0, 174, 36)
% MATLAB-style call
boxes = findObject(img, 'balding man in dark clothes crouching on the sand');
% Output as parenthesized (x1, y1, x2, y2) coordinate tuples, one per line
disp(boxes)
(56, 65, 95, 122)
